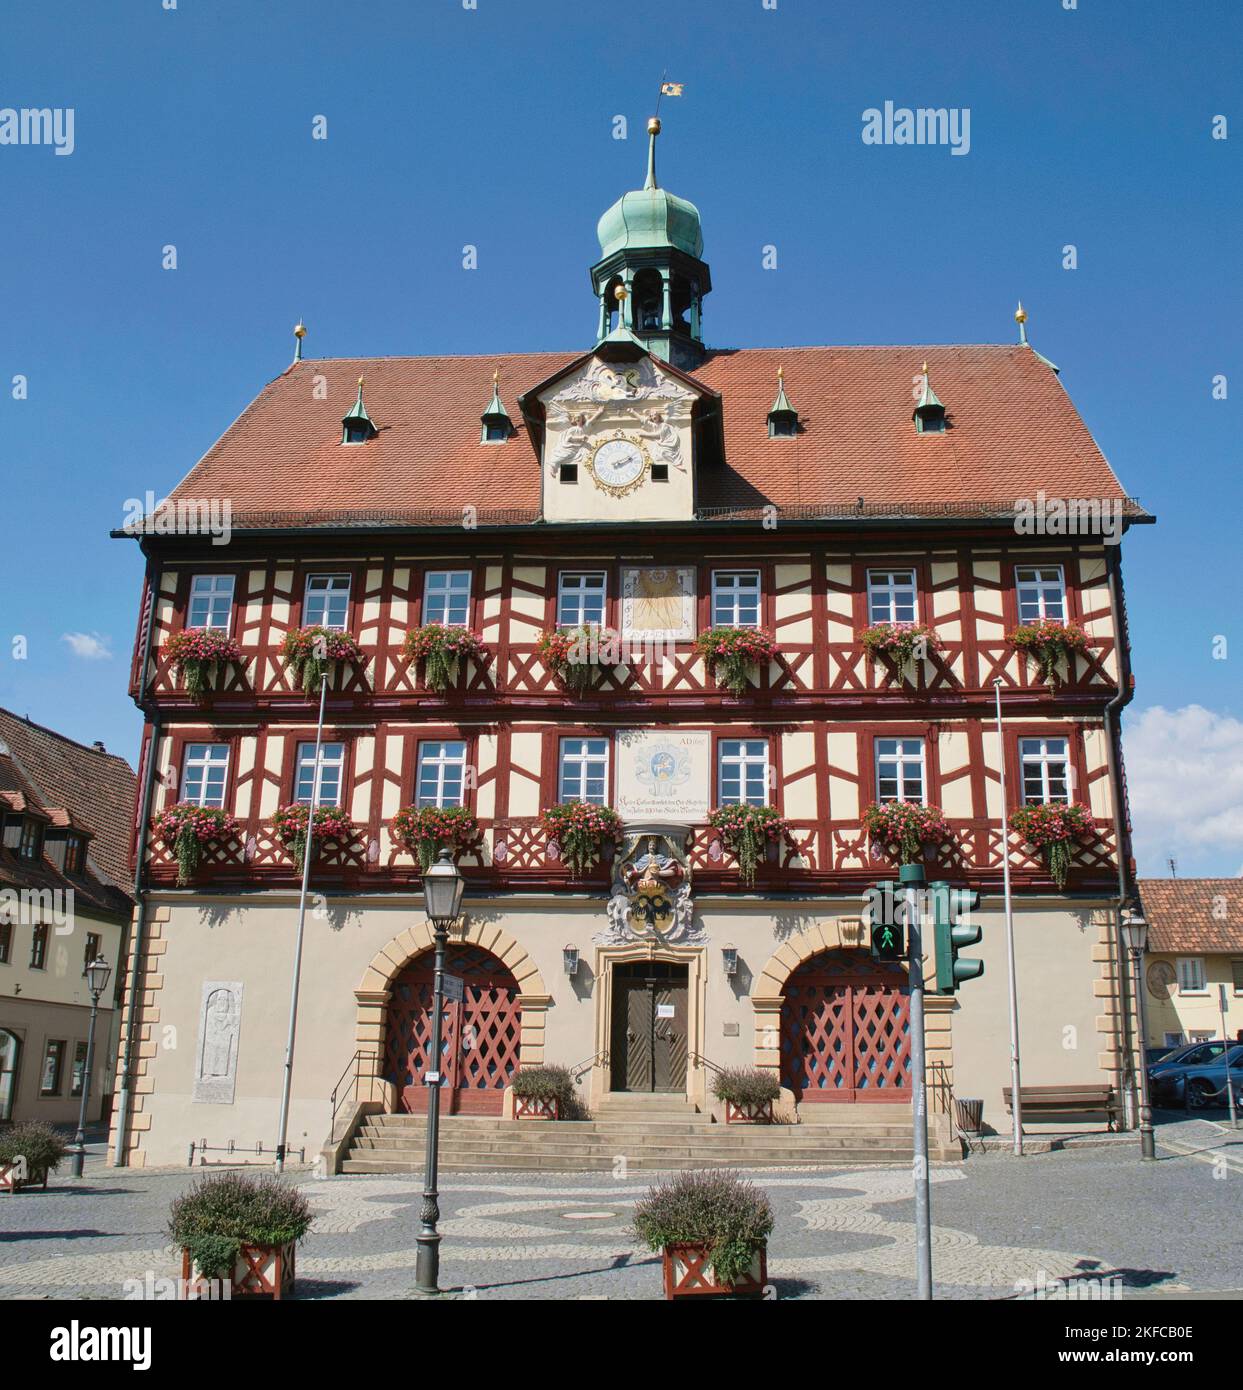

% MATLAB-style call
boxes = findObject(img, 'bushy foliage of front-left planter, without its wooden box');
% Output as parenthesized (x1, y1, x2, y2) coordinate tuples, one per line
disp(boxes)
(168, 1173, 313, 1279)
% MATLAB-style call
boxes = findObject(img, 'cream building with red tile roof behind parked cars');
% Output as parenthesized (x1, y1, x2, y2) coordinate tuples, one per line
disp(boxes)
(1139, 878, 1243, 1047)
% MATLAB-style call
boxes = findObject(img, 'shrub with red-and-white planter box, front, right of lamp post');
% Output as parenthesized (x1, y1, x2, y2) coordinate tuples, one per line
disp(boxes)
(634, 1169, 773, 1298)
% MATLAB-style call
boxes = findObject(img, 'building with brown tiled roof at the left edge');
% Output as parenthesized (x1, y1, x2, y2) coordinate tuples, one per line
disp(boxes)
(0, 709, 136, 1125)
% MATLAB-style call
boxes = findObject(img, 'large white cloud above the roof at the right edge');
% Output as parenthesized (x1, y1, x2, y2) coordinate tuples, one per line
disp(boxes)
(1122, 705, 1243, 877)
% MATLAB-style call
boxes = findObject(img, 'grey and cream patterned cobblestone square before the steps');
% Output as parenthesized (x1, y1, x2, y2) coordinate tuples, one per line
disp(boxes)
(0, 1119, 1243, 1298)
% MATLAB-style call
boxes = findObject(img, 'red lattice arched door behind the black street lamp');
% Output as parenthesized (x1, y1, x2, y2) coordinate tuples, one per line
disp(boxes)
(384, 945, 523, 1115)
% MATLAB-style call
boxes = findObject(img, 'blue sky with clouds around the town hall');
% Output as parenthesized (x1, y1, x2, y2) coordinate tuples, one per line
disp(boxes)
(0, 0, 1243, 874)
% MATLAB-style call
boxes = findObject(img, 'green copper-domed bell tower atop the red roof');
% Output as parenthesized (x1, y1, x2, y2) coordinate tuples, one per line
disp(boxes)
(591, 115, 712, 371)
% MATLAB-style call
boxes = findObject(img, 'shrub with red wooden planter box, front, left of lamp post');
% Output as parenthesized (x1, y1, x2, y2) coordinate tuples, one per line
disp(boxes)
(168, 1173, 311, 1298)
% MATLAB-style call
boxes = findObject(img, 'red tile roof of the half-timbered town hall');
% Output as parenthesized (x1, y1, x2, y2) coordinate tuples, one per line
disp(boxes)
(158, 346, 1145, 527)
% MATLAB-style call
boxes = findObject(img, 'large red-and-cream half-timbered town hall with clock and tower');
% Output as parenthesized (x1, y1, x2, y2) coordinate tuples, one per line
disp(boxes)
(114, 119, 1151, 1163)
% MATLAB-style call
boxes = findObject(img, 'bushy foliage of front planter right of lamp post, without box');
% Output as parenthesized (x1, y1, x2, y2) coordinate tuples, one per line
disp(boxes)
(634, 1169, 773, 1283)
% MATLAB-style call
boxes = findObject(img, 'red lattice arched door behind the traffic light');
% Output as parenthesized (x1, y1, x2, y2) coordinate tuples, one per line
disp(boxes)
(781, 951, 911, 1104)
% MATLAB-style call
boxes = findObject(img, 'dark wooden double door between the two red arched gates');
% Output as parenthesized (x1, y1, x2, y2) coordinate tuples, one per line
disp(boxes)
(612, 960, 688, 1091)
